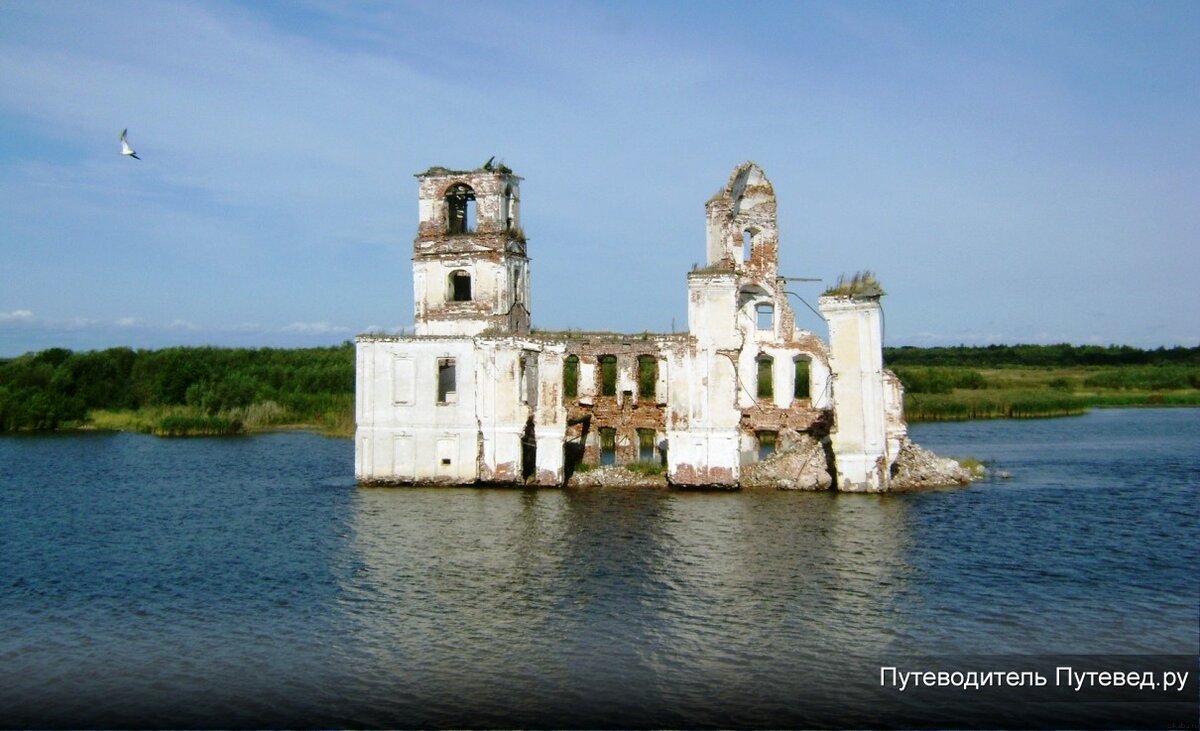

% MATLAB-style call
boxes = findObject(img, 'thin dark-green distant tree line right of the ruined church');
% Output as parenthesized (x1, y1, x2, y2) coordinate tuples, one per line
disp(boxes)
(883, 343, 1200, 369)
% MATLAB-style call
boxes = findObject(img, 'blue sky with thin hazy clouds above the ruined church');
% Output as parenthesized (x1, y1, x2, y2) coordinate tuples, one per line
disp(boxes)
(0, 0, 1200, 356)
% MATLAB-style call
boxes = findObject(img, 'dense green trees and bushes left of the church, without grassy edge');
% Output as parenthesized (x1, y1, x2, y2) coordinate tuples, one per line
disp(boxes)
(0, 343, 354, 431)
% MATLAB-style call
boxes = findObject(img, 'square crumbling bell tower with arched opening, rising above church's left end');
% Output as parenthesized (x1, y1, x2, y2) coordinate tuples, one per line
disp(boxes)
(413, 160, 529, 336)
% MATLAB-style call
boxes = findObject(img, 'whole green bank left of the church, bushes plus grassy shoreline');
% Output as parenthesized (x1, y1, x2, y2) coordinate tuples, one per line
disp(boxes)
(0, 343, 354, 436)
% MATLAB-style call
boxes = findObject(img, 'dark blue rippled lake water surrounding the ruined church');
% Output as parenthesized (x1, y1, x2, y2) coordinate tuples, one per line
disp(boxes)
(0, 409, 1200, 727)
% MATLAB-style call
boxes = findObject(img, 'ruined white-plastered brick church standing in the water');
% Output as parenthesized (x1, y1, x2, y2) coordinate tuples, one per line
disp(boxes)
(355, 162, 926, 491)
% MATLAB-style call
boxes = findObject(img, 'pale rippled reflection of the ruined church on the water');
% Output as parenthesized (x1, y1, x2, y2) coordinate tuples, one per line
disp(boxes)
(343, 489, 921, 726)
